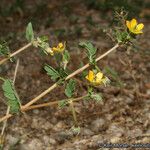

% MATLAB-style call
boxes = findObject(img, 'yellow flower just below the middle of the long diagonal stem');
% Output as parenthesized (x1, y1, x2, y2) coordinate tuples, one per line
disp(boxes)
(85, 70, 107, 86)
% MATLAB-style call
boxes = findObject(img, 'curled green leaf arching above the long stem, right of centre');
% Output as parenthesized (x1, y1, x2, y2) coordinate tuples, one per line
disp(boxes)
(79, 42, 97, 64)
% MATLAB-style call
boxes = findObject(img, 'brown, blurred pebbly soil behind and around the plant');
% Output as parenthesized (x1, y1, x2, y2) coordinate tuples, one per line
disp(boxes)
(0, 0, 150, 150)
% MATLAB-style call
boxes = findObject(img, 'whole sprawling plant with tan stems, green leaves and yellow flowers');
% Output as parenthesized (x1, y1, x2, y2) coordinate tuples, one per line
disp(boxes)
(0, 12, 144, 144)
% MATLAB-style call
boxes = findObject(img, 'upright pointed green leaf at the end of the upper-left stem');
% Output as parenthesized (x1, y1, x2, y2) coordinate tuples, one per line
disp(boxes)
(26, 22, 34, 42)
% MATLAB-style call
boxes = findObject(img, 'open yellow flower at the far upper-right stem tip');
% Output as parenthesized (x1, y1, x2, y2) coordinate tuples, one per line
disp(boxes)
(126, 19, 144, 34)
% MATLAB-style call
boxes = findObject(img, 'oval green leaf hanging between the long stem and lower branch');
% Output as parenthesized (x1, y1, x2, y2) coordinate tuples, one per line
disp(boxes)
(65, 79, 76, 98)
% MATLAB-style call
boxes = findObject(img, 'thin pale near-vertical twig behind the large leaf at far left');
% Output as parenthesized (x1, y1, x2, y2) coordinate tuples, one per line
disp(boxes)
(1, 59, 19, 137)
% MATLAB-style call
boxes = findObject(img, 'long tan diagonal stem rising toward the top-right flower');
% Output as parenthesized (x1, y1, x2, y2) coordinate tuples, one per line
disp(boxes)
(0, 44, 119, 122)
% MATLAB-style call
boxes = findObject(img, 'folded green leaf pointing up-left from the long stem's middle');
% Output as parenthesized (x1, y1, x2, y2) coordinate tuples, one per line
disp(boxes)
(44, 65, 60, 81)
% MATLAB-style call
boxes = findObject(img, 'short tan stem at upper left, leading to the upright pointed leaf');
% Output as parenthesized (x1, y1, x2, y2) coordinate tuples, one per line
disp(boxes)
(0, 43, 32, 65)
